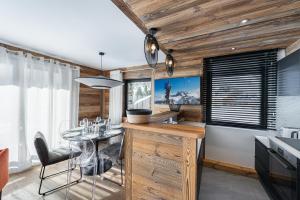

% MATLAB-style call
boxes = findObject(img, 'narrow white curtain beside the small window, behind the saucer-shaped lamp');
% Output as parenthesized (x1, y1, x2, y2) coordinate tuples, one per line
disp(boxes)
(109, 70, 123, 124)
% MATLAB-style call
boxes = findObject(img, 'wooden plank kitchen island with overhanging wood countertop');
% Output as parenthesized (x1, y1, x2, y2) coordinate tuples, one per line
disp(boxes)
(123, 123, 205, 200)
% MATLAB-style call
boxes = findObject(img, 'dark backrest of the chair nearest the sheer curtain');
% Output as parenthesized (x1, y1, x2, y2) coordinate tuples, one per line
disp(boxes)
(34, 132, 49, 166)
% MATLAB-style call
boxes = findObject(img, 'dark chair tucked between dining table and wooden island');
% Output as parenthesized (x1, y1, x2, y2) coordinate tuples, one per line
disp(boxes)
(99, 131, 125, 186)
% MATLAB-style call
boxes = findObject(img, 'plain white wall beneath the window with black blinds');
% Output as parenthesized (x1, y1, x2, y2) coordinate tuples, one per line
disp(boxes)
(205, 125, 274, 168)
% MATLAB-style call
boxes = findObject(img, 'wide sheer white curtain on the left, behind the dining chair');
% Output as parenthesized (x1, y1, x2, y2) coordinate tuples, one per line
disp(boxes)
(0, 47, 79, 173)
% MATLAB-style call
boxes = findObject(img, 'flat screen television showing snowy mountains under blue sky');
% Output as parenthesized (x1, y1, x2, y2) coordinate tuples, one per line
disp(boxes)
(154, 76, 200, 105)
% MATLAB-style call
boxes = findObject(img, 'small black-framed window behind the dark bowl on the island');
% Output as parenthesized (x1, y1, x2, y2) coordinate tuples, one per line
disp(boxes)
(125, 79, 151, 109)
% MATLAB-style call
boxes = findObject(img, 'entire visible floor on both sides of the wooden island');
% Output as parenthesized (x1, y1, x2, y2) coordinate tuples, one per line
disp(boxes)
(3, 166, 269, 200)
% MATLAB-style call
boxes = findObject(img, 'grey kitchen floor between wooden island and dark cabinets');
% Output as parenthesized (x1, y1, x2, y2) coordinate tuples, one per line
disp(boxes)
(200, 168, 269, 200)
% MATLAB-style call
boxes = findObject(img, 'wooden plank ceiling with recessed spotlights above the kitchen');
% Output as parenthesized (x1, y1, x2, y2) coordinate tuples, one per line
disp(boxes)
(112, 0, 300, 62)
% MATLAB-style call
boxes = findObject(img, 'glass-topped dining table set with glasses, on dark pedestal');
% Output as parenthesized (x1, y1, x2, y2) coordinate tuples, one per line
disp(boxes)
(62, 125, 124, 176)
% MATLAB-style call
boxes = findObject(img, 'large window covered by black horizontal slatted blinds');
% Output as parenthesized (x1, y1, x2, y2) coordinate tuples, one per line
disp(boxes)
(204, 50, 277, 129)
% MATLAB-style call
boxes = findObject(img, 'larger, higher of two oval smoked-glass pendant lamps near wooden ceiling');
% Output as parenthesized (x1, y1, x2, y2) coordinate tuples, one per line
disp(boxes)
(144, 28, 159, 68)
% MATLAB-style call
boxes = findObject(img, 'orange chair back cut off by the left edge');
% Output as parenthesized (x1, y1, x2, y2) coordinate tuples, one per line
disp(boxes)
(0, 149, 8, 190)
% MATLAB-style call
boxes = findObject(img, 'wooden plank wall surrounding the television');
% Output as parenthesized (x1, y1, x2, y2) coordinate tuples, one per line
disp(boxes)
(123, 59, 203, 122)
